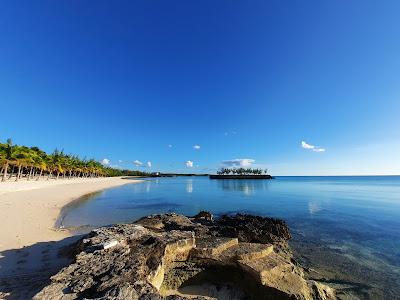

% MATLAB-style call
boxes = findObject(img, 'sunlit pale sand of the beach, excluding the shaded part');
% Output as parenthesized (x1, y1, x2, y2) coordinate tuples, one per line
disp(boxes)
(0, 177, 141, 253)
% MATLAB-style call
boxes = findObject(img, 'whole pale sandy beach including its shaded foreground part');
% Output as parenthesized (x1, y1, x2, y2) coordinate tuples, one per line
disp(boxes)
(0, 177, 140, 299)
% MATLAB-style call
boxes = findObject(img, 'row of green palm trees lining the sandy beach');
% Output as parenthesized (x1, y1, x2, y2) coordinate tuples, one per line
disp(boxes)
(0, 139, 150, 181)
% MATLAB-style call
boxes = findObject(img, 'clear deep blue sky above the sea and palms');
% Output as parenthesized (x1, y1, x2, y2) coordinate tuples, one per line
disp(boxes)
(0, 0, 400, 175)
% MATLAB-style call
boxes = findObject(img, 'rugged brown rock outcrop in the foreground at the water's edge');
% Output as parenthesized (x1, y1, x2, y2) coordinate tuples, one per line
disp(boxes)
(35, 213, 335, 300)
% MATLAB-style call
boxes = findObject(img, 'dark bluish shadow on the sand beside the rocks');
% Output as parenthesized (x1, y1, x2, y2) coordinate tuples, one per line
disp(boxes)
(0, 236, 81, 299)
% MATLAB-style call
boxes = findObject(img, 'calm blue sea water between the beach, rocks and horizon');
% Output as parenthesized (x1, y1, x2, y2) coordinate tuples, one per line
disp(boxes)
(60, 176, 400, 299)
